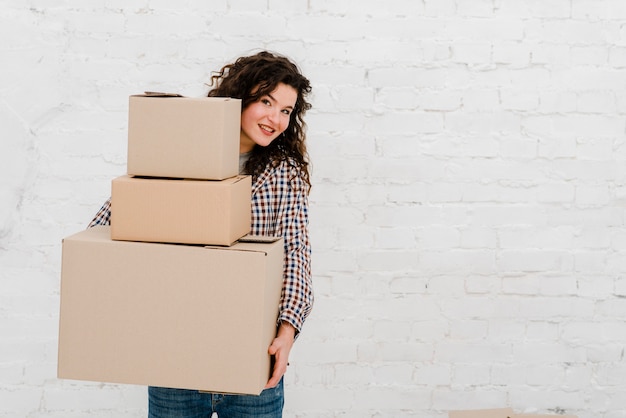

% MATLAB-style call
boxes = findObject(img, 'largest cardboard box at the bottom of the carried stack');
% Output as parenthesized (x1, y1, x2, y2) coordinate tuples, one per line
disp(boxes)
(58, 226, 284, 394)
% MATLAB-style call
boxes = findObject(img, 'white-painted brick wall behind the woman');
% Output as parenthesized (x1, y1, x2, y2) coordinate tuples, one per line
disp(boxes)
(0, 0, 626, 418)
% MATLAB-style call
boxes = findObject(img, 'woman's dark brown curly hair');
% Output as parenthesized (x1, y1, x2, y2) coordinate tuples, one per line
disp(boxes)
(208, 51, 311, 185)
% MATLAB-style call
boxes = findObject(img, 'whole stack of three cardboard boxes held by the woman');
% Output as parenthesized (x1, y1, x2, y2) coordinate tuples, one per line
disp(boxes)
(58, 94, 283, 394)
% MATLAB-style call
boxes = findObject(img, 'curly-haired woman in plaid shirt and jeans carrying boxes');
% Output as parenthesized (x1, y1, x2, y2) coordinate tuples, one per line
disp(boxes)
(90, 51, 313, 418)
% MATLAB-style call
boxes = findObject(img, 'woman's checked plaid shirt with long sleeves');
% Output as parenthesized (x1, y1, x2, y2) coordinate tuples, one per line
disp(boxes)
(89, 161, 313, 334)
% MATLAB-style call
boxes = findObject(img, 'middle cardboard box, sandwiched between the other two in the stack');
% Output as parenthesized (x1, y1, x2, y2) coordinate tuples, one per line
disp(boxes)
(111, 176, 252, 245)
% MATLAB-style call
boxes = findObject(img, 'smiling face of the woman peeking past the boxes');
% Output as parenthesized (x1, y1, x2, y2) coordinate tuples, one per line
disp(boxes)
(239, 83, 298, 153)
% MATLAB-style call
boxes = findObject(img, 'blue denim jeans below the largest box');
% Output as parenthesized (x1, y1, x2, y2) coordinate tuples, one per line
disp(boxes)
(148, 379, 285, 418)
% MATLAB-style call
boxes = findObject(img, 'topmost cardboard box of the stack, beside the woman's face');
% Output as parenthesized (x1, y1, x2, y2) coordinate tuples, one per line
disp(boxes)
(127, 95, 241, 180)
